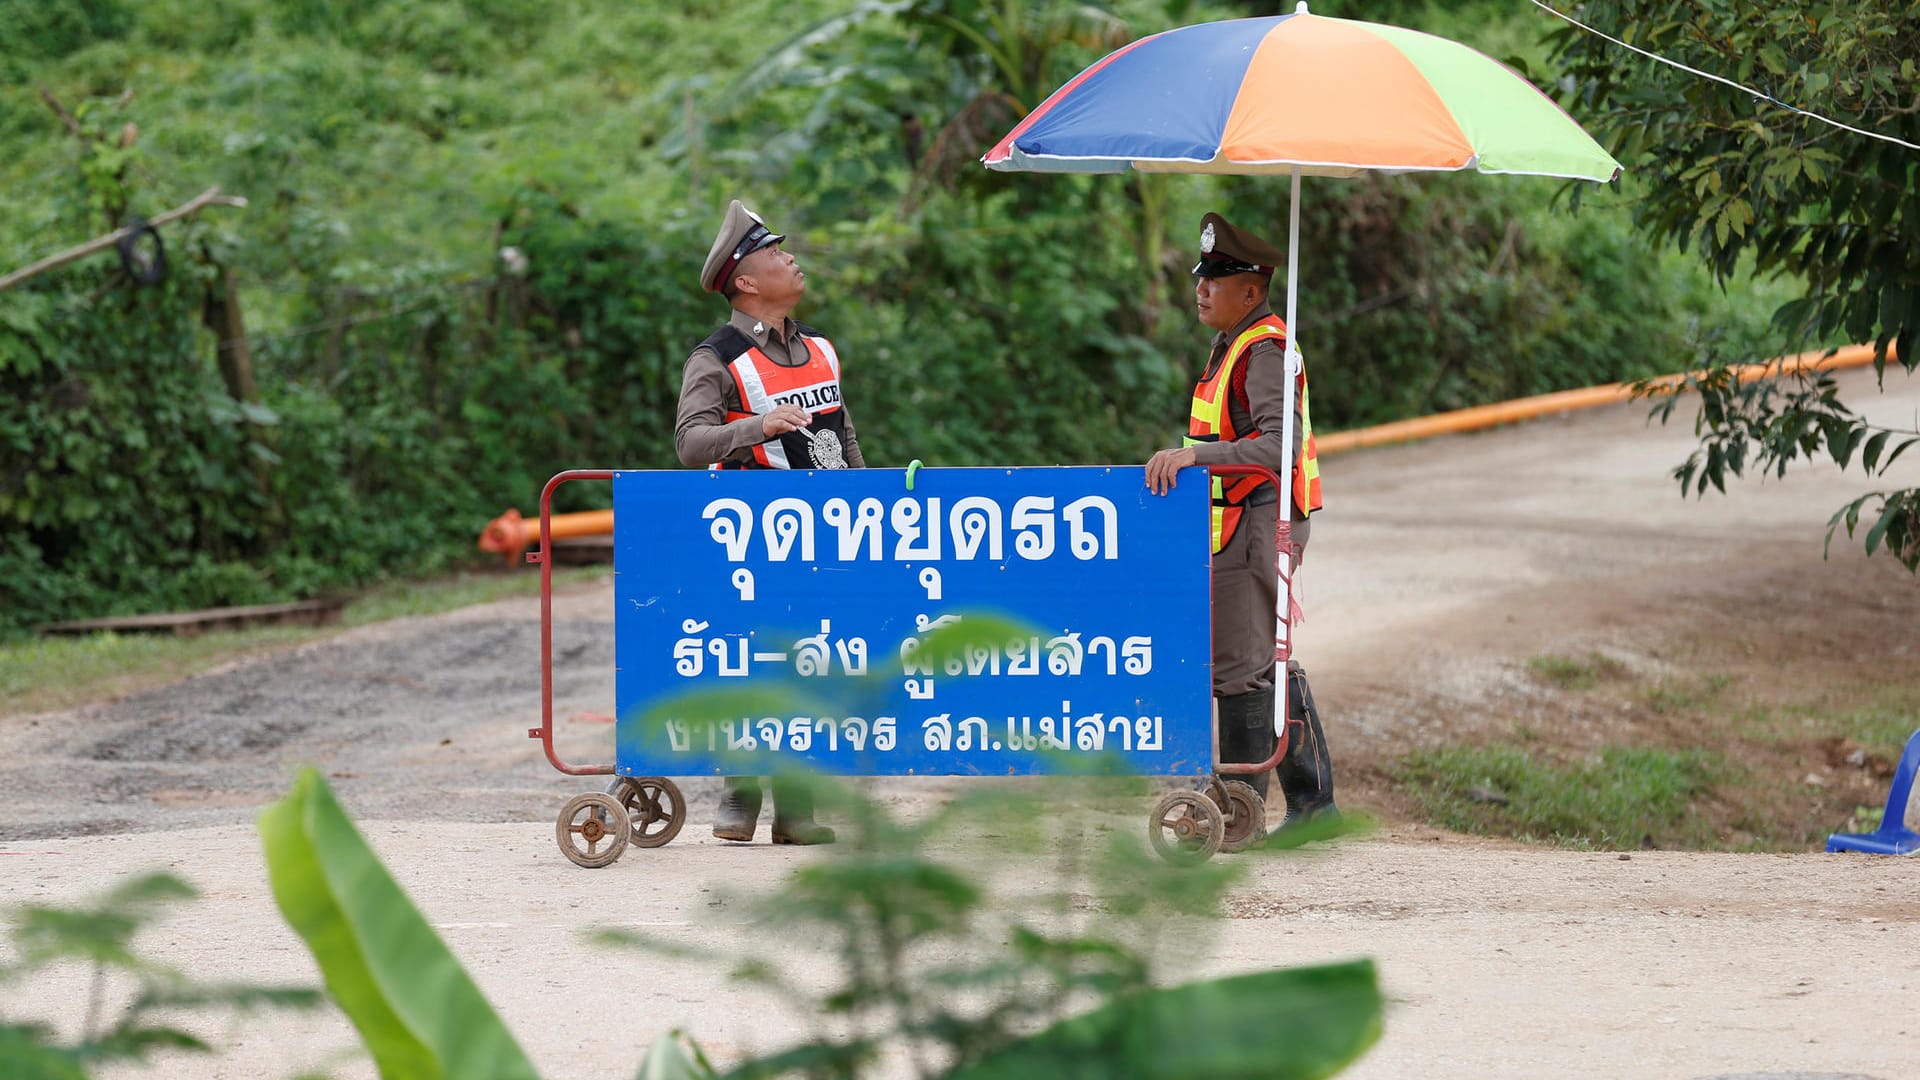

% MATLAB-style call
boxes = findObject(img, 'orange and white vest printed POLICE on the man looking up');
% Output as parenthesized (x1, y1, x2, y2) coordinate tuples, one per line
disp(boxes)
(705, 323, 847, 469)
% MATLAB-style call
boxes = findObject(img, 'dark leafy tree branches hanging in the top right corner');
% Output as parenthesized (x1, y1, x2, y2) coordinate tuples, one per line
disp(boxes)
(1553, 0, 1920, 571)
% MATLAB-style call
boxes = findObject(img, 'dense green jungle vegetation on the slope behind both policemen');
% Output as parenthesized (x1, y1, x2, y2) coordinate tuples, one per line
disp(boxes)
(0, 0, 1799, 634)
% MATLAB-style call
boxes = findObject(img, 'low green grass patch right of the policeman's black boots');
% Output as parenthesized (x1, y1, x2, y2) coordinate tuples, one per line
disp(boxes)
(1396, 746, 1728, 851)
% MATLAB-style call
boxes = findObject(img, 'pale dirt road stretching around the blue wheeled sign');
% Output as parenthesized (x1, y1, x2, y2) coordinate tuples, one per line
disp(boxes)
(0, 363, 1920, 1080)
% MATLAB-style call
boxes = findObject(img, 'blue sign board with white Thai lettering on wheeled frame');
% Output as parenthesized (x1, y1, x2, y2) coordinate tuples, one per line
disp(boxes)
(612, 467, 1213, 776)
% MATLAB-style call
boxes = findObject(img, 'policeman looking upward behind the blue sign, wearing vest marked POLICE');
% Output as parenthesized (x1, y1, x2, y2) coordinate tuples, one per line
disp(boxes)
(674, 200, 866, 844)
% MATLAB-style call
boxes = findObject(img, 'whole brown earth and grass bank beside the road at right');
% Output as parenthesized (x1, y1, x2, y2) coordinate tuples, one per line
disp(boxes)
(1388, 653, 1920, 851)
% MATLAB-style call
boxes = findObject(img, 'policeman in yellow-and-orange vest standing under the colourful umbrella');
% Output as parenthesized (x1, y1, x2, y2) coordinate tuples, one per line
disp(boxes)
(1146, 213, 1334, 832)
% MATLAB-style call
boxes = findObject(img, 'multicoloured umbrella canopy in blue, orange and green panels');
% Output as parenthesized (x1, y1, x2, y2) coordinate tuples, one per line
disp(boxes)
(983, 13, 1620, 181)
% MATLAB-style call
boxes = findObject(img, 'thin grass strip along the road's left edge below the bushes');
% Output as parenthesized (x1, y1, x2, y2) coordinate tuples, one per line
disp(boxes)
(0, 567, 609, 717)
